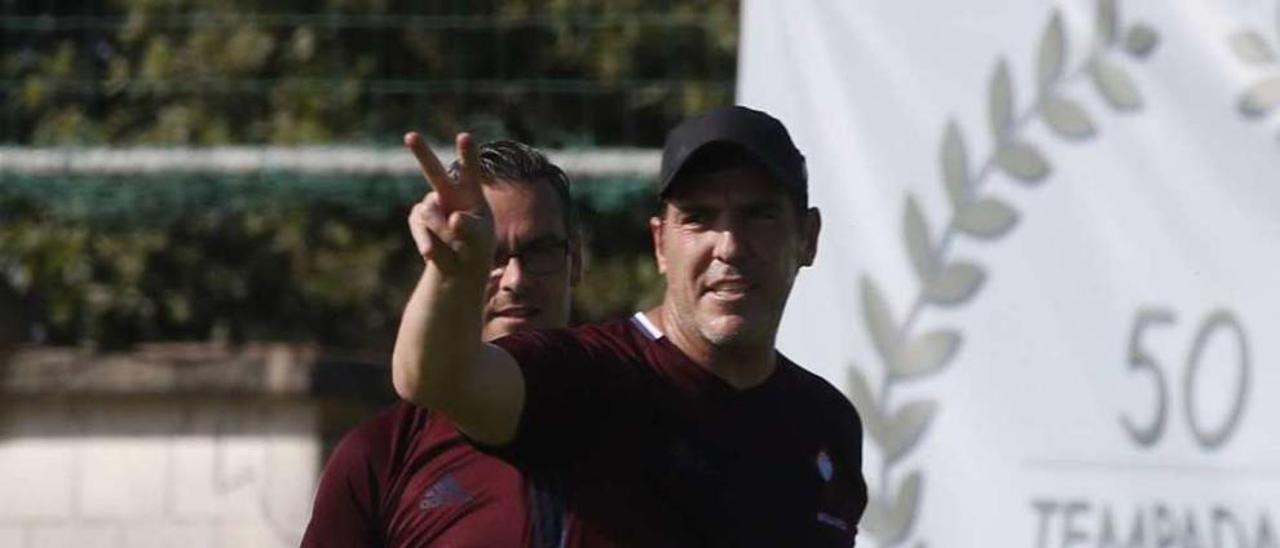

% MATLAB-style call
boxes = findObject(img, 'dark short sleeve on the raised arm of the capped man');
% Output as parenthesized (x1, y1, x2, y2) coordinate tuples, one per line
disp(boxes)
(486, 329, 621, 465)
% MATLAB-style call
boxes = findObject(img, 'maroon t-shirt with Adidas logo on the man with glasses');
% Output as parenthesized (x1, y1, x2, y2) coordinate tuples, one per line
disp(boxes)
(302, 402, 563, 548)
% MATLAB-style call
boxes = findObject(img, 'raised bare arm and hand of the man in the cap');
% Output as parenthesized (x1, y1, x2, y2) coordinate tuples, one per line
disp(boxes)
(392, 133, 525, 444)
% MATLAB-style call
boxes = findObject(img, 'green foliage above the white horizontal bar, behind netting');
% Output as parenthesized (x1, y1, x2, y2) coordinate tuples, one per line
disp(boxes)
(0, 0, 737, 147)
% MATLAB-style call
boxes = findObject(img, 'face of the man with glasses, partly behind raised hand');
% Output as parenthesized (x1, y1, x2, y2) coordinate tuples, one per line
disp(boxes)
(481, 181, 580, 341)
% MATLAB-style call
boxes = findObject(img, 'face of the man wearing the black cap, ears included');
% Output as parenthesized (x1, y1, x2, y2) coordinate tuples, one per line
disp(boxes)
(649, 166, 820, 347)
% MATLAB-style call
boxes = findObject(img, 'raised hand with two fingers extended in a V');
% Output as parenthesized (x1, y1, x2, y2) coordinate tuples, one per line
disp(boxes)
(404, 132, 494, 279)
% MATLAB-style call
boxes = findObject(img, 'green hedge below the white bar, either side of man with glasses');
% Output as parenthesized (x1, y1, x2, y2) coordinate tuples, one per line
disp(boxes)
(0, 174, 660, 352)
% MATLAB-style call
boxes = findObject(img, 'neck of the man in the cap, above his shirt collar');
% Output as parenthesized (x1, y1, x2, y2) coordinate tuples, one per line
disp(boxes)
(645, 306, 778, 391)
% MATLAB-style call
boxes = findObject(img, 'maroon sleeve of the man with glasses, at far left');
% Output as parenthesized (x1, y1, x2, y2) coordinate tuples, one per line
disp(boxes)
(302, 423, 384, 548)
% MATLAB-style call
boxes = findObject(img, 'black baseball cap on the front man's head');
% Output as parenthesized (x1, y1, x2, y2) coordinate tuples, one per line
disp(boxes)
(658, 105, 809, 206)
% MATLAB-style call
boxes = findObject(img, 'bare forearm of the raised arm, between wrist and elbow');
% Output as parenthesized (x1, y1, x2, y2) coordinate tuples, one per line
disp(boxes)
(392, 261, 485, 410)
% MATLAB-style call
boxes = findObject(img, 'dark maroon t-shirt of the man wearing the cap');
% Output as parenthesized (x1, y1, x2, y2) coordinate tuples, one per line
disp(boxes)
(493, 315, 867, 547)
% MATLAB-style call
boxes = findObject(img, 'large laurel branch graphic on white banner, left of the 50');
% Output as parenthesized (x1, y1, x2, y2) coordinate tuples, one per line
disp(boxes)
(847, 0, 1162, 548)
